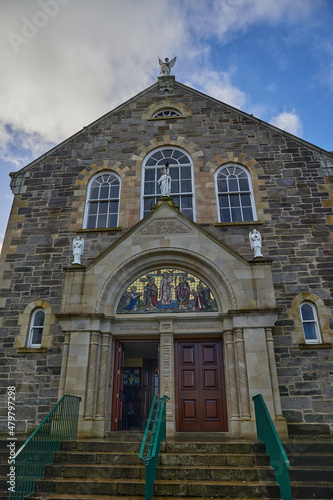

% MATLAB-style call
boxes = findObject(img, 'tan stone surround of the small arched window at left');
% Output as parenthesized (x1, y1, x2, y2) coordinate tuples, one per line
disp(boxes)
(14, 299, 55, 354)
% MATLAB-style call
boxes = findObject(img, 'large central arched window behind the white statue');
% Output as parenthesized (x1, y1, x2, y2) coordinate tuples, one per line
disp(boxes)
(141, 148, 195, 220)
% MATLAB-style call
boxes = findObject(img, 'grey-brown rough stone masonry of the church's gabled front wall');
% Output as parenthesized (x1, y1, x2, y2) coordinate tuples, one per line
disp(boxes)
(0, 82, 333, 434)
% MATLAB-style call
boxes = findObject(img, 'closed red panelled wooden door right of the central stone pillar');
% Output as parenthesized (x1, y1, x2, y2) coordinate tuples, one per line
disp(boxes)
(176, 340, 228, 432)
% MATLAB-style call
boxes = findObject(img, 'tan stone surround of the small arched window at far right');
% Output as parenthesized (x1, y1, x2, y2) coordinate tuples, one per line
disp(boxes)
(287, 292, 333, 349)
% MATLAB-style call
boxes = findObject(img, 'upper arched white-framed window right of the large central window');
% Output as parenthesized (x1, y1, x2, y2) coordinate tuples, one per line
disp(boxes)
(215, 165, 256, 222)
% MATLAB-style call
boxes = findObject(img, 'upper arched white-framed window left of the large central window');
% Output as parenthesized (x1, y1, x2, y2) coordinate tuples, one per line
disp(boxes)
(84, 172, 120, 229)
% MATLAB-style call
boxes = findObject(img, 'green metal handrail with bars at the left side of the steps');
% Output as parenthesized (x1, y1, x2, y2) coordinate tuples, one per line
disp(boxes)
(9, 394, 81, 500)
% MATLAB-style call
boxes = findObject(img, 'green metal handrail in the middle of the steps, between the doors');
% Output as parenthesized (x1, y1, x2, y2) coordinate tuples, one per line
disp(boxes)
(139, 396, 169, 500)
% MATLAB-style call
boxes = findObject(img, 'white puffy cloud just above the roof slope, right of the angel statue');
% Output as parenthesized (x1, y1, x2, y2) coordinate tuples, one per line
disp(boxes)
(186, 71, 246, 109)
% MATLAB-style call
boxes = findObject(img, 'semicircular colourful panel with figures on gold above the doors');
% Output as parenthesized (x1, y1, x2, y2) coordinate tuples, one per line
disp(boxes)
(117, 268, 217, 314)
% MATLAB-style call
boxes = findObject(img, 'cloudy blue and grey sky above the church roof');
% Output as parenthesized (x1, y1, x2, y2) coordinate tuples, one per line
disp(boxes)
(0, 0, 333, 250)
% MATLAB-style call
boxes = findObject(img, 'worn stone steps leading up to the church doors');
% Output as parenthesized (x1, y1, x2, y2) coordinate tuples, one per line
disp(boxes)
(1, 433, 333, 500)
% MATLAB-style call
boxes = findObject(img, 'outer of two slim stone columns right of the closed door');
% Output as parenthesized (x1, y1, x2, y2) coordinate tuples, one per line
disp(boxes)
(234, 328, 251, 418)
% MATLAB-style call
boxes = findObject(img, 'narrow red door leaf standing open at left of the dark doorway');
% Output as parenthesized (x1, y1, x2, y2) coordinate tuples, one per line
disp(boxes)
(111, 341, 124, 431)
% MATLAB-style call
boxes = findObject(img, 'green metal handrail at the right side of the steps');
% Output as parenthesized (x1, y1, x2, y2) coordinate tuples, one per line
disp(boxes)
(253, 394, 292, 500)
